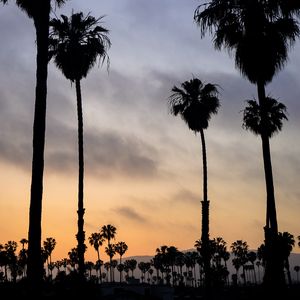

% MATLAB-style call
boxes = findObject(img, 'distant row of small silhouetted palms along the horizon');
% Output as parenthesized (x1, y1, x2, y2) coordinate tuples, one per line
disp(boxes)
(0, 230, 300, 293)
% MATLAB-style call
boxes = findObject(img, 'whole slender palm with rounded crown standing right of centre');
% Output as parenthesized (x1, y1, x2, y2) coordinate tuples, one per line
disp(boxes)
(170, 78, 220, 289)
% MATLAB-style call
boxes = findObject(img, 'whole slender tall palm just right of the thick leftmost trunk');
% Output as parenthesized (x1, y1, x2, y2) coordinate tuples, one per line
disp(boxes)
(50, 13, 110, 277)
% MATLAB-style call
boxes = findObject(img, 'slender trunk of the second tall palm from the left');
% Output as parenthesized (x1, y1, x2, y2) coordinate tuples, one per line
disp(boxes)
(75, 79, 85, 279)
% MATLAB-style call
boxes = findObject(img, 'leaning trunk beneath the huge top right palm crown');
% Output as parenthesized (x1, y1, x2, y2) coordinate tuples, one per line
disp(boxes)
(257, 82, 285, 288)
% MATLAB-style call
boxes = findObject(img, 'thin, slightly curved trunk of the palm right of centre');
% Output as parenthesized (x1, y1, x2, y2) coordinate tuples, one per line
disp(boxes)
(200, 129, 211, 292)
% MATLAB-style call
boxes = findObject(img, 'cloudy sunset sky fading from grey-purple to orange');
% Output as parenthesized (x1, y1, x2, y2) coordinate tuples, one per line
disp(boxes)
(0, 0, 300, 261)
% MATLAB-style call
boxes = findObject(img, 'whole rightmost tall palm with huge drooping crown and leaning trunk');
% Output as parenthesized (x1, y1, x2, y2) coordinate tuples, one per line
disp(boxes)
(194, 0, 300, 288)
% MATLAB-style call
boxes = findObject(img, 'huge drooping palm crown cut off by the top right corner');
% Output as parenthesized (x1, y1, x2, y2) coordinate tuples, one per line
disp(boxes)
(194, 0, 300, 84)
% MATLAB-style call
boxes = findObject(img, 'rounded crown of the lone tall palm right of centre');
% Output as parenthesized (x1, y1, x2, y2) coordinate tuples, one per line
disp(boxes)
(170, 78, 220, 132)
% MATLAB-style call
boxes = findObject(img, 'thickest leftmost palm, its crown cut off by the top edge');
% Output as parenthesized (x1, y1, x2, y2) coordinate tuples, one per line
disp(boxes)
(0, 0, 66, 287)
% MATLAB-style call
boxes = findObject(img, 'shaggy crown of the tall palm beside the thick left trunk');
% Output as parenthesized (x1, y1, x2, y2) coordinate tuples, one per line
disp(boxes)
(50, 13, 111, 81)
